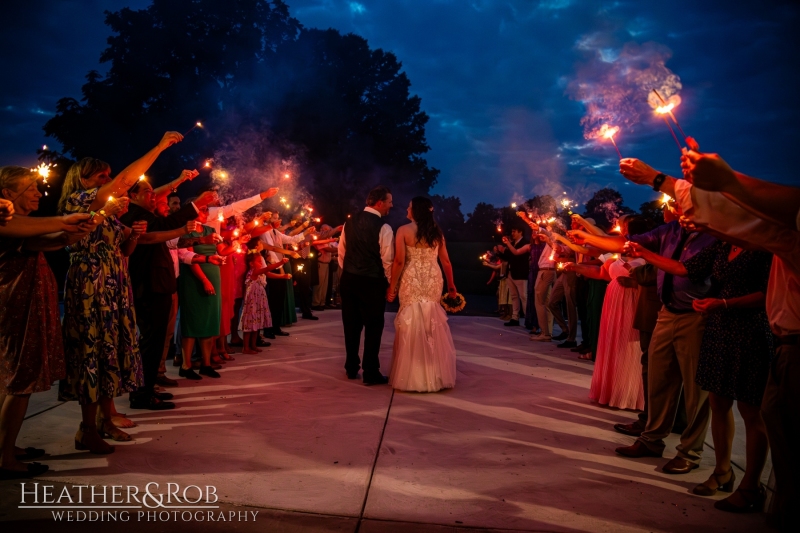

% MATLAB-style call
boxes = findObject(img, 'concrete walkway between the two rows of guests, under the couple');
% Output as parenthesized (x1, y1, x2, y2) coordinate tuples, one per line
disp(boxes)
(0, 311, 764, 532)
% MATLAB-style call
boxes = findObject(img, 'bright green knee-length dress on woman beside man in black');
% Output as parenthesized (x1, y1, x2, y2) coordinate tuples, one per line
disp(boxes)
(178, 226, 222, 339)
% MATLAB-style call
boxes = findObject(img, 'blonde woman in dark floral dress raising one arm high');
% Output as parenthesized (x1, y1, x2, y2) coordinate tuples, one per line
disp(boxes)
(58, 132, 183, 454)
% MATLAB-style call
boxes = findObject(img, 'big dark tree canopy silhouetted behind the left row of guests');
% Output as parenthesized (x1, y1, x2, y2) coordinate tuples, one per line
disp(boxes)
(45, 0, 438, 221)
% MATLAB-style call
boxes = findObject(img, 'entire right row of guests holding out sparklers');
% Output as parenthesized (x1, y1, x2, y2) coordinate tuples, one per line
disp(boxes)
(483, 139, 800, 531)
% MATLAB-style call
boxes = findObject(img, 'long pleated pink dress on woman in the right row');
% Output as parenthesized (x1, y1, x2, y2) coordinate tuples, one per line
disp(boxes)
(589, 259, 644, 410)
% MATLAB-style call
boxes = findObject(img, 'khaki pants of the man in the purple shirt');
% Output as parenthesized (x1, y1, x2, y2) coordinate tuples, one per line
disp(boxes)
(639, 307, 711, 463)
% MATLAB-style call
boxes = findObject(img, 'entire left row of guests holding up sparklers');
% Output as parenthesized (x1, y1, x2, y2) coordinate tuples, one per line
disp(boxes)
(0, 132, 342, 470)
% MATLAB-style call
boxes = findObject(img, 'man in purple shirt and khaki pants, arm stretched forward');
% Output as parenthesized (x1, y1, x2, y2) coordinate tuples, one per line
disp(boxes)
(569, 221, 716, 474)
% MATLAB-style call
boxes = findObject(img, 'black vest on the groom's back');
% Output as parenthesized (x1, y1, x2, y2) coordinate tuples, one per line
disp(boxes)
(344, 211, 385, 278)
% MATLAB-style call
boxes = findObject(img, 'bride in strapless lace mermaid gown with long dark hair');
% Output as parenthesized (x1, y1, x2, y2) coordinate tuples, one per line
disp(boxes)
(386, 196, 456, 392)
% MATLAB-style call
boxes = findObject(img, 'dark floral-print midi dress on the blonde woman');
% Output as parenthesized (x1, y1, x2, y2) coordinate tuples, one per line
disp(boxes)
(58, 189, 143, 405)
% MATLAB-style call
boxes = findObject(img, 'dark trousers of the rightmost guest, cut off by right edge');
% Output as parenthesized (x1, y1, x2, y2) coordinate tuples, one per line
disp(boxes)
(761, 344, 800, 531)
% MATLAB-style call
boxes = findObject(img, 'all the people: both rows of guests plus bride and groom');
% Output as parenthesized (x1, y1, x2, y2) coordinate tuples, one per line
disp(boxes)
(0, 128, 800, 530)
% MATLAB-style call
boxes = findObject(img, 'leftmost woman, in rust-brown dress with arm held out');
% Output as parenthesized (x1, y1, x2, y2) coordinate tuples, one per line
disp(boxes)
(0, 166, 95, 479)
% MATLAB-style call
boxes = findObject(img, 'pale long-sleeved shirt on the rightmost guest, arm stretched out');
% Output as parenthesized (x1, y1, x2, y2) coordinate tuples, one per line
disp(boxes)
(675, 180, 800, 335)
